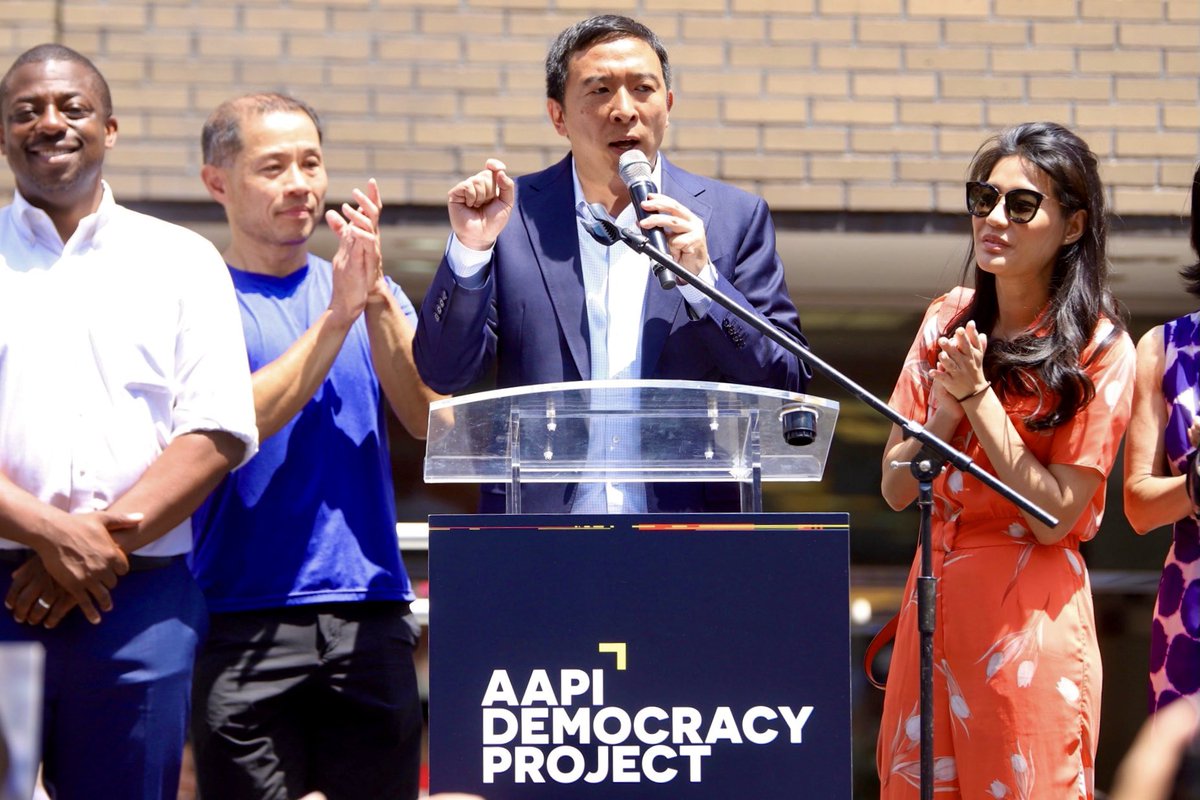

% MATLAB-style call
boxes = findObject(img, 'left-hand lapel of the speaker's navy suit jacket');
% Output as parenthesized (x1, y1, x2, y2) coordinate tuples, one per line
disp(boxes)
(517, 156, 592, 380)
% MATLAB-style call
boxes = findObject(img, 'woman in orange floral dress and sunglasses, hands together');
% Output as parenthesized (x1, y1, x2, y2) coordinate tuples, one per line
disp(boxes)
(877, 122, 1134, 800)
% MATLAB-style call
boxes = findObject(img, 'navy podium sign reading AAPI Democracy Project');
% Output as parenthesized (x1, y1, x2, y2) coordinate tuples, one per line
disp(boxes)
(430, 513, 851, 800)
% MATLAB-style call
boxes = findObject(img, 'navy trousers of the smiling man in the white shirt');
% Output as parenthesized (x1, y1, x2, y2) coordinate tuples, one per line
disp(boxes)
(0, 558, 208, 800)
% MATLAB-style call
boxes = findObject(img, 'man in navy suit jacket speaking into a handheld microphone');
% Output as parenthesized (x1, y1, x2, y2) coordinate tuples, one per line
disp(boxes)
(413, 14, 809, 512)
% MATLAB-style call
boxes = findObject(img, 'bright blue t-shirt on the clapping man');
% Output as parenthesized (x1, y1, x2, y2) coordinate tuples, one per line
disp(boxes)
(191, 255, 416, 612)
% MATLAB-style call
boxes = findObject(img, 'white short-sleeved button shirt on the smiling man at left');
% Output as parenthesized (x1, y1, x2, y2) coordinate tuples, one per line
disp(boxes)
(0, 184, 258, 555)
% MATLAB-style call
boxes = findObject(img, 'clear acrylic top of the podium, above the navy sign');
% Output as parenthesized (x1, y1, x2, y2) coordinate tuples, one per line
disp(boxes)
(425, 380, 838, 513)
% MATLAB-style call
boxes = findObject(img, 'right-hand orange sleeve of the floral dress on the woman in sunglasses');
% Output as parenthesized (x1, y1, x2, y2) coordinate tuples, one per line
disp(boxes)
(1049, 319, 1138, 477)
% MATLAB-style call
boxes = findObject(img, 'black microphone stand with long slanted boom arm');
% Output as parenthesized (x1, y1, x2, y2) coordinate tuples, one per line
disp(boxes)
(595, 211, 1058, 800)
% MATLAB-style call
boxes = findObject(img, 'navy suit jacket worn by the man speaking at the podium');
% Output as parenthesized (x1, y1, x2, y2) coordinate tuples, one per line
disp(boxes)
(413, 156, 809, 512)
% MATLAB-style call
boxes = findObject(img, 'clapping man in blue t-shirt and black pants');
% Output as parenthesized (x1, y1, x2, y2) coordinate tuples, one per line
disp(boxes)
(184, 94, 436, 800)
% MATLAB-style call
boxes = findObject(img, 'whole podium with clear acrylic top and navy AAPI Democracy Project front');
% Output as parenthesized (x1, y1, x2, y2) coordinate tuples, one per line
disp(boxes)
(425, 380, 852, 800)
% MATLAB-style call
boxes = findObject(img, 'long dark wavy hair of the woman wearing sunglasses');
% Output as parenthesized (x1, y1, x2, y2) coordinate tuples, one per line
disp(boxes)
(943, 122, 1124, 431)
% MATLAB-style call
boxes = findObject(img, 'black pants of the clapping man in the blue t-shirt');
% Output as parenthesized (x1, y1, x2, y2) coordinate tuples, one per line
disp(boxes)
(192, 602, 422, 800)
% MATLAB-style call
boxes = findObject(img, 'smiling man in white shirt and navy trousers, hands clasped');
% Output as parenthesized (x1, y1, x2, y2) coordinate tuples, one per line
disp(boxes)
(0, 44, 257, 800)
